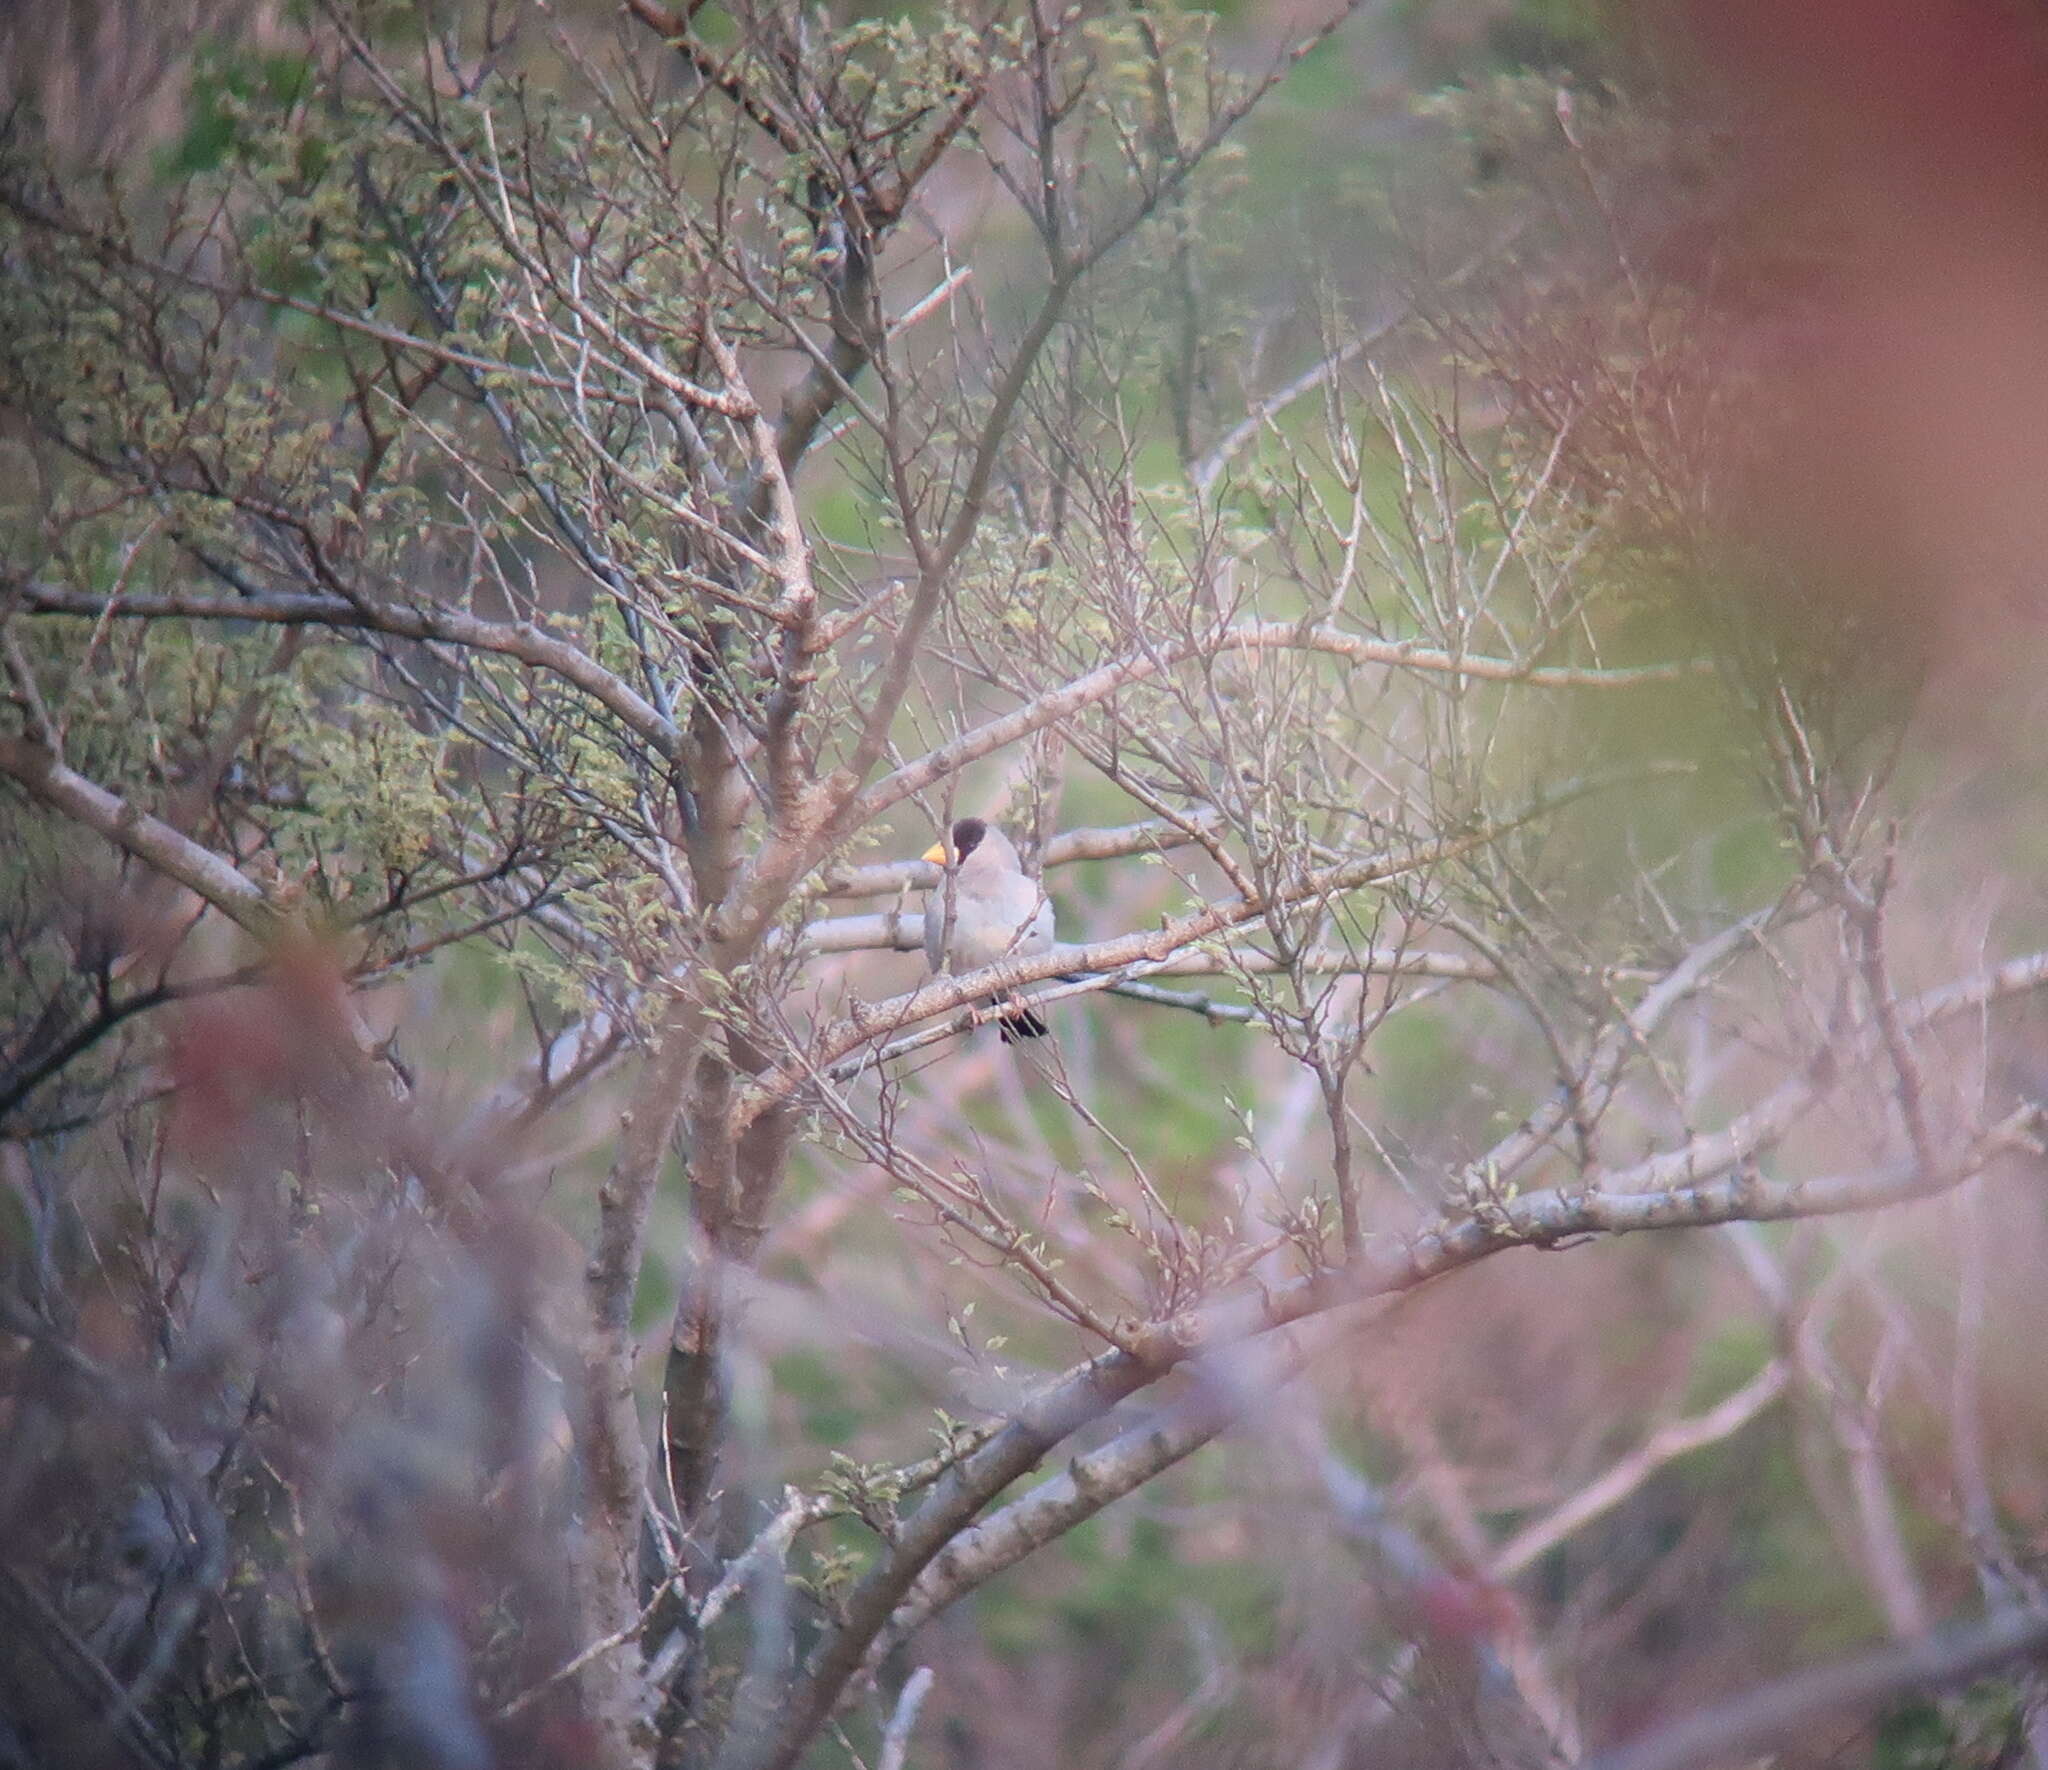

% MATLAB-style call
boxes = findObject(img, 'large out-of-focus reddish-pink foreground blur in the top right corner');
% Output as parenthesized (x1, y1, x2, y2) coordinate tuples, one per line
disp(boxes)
(1669, 0, 2048, 666)
